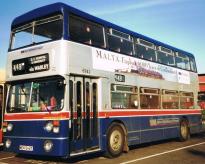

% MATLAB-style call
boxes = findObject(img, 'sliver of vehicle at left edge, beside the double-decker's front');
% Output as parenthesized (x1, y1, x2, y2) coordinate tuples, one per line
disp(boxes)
(0, 69, 6, 146)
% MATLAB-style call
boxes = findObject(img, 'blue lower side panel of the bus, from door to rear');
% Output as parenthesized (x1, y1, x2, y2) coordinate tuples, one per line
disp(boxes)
(100, 115, 202, 150)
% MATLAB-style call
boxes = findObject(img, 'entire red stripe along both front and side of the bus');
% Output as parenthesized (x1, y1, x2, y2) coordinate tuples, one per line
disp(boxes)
(4, 109, 201, 121)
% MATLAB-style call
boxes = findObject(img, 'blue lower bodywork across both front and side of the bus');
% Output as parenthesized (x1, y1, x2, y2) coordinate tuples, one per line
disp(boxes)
(4, 115, 202, 156)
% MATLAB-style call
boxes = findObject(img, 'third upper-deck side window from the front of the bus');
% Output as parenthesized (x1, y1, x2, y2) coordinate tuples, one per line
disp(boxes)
(135, 39, 156, 61)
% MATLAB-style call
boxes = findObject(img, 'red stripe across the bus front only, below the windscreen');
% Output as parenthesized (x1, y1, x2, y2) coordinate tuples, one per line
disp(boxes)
(4, 112, 70, 121)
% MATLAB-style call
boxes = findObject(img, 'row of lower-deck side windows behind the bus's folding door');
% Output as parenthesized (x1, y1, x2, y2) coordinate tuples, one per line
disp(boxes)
(111, 84, 194, 109)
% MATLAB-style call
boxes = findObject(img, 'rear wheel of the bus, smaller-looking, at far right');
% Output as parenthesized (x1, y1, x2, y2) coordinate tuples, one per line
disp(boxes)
(179, 119, 190, 141)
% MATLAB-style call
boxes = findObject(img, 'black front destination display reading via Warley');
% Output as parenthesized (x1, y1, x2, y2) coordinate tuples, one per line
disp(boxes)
(12, 54, 49, 76)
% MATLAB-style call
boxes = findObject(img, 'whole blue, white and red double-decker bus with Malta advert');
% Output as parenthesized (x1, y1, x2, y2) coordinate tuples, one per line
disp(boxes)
(4, 3, 202, 157)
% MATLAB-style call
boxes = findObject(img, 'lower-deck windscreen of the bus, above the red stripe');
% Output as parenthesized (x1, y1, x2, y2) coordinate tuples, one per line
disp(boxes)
(7, 79, 65, 113)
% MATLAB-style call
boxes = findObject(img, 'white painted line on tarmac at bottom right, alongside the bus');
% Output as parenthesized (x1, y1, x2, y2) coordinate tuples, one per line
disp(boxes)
(120, 142, 205, 164)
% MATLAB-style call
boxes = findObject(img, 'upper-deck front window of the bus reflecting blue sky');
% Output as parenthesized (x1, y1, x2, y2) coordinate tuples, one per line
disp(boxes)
(10, 15, 63, 49)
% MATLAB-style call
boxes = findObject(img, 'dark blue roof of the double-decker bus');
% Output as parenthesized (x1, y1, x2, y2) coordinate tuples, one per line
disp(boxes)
(11, 3, 194, 58)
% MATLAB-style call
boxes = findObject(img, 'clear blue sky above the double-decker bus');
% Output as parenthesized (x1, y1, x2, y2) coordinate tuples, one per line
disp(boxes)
(0, 0, 205, 73)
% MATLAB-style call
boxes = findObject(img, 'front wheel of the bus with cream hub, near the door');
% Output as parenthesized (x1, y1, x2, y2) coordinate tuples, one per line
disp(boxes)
(107, 123, 125, 158)
